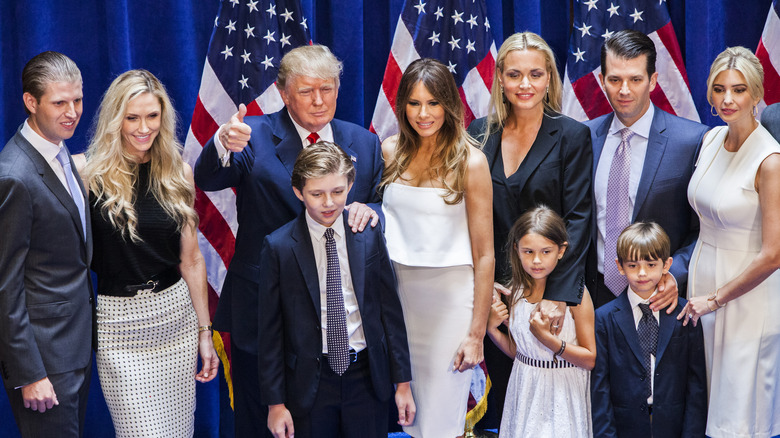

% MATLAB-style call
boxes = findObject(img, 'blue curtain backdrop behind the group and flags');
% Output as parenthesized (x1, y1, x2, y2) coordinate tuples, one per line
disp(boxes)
(0, 0, 772, 437)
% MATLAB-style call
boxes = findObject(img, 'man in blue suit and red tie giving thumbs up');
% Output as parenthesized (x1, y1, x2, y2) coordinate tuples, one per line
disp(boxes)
(194, 45, 383, 437)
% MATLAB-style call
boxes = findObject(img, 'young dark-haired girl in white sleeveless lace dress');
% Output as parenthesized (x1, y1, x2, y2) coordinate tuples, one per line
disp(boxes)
(488, 207, 596, 438)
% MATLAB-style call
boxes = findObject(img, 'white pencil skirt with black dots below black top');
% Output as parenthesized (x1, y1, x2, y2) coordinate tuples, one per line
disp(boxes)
(96, 279, 198, 438)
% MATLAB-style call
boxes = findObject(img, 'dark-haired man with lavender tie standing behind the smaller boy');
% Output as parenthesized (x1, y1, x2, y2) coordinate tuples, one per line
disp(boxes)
(585, 30, 707, 311)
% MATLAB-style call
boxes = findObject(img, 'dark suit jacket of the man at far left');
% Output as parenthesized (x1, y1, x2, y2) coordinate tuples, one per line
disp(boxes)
(0, 131, 96, 388)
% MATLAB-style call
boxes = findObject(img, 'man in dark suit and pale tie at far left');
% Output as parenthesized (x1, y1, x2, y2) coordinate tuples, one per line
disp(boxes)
(0, 52, 96, 438)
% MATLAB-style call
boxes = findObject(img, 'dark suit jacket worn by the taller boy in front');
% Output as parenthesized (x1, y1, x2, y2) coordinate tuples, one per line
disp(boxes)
(258, 214, 412, 416)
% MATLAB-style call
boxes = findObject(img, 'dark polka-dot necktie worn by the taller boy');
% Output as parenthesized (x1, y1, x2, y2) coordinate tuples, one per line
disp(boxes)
(325, 228, 349, 376)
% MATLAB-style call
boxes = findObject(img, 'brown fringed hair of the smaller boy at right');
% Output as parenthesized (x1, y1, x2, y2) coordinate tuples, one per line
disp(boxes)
(617, 222, 671, 264)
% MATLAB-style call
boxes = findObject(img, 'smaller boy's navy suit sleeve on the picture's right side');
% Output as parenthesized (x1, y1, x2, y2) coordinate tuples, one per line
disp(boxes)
(682, 324, 707, 438)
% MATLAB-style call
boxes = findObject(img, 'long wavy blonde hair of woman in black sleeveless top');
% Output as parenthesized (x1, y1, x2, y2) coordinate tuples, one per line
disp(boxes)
(85, 70, 198, 243)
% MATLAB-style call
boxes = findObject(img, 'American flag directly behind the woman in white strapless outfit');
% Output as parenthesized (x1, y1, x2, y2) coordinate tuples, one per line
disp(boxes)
(371, 0, 496, 140)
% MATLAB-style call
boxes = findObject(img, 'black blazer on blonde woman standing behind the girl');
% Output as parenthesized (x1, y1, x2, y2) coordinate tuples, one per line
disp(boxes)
(468, 113, 593, 304)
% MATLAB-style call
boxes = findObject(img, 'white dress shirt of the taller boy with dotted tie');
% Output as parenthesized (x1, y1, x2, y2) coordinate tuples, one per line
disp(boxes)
(306, 210, 366, 354)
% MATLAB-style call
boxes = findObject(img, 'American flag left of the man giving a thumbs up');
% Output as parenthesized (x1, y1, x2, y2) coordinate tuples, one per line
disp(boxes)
(183, 0, 311, 400)
